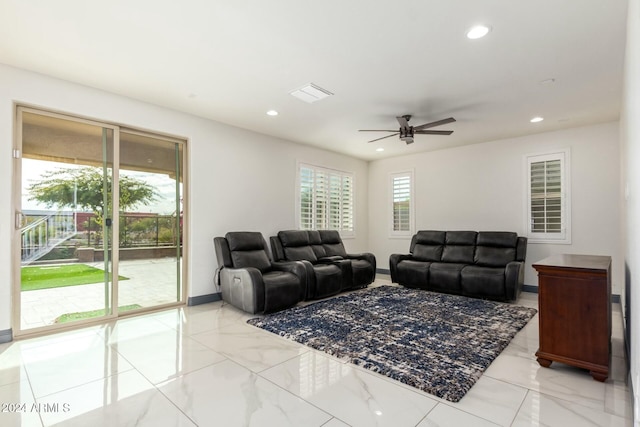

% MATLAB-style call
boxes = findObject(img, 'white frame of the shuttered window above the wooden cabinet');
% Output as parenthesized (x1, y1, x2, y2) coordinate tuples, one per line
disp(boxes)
(524, 148, 571, 244)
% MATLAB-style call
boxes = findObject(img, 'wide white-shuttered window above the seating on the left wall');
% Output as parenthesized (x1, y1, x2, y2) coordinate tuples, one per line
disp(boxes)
(298, 164, 354, 236)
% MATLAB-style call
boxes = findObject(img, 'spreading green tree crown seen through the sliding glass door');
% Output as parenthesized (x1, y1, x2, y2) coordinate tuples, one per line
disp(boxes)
(27, 166, 157, 224)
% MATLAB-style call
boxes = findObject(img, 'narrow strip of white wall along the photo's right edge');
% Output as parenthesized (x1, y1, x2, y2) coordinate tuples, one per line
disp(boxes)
(620, 0, 640, 425)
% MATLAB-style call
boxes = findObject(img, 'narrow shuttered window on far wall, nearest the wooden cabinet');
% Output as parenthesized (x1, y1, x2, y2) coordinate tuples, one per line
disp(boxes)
(527, 149, 571, 243)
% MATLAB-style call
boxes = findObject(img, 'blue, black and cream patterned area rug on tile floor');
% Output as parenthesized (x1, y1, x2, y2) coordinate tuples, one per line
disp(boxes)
(248, 286, 536, 402)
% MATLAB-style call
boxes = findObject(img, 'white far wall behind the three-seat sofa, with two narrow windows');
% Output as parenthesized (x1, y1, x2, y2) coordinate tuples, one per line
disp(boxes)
(369, 123, 623, 294)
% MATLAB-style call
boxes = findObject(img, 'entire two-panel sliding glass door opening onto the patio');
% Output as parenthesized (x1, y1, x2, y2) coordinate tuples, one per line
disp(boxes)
(13, 108, 184, 335)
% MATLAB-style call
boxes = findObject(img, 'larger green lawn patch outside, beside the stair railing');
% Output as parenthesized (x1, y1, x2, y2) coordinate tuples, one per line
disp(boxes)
(21, 264, 128, 291)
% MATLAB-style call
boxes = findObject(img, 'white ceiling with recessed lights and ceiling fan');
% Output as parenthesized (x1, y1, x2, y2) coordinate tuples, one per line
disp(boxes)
(0, 0, 627, 160)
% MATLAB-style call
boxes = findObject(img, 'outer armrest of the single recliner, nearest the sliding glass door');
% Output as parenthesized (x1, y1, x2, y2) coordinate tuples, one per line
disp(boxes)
(220, 267, 264, 314)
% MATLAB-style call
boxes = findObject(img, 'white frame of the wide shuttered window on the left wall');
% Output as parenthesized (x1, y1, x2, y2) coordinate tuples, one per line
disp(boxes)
(296, 162, 356, 238)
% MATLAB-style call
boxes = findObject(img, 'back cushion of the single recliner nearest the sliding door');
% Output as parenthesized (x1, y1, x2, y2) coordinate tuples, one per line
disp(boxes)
(225, 231, 271, 273)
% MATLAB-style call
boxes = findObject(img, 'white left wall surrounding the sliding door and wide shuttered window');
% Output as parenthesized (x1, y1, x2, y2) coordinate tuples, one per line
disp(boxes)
(0, 64, 368, 331)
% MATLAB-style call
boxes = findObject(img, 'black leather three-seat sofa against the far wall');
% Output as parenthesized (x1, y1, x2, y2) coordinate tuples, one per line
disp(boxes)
(389, 230, 527, 301)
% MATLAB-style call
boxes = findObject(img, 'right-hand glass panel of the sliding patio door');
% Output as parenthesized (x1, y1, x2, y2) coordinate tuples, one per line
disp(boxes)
(118, 130, 183, 309)
